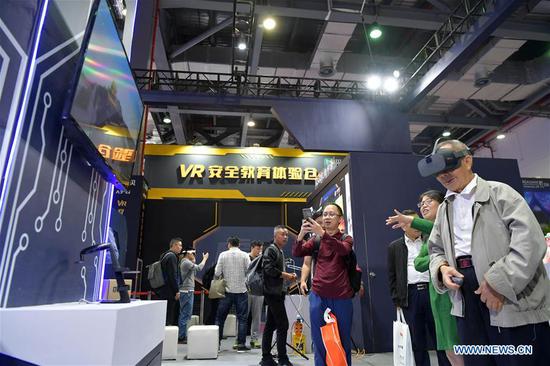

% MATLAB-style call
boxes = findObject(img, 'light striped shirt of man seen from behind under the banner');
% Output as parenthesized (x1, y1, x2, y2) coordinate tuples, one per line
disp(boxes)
(215, 247, 250, 294)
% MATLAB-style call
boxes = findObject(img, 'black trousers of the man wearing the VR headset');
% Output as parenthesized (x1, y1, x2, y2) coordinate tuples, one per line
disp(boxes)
(457, 267, 550, 366)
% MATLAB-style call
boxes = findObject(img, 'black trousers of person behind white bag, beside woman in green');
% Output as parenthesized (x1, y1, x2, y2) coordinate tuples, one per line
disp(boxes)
(403, 283, 451, 366)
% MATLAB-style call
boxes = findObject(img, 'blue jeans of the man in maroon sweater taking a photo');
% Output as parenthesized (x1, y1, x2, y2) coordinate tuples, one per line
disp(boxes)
(309, 291, 353, 366)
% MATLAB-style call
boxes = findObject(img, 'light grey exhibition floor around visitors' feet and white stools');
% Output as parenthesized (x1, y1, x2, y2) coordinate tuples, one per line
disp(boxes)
(162, 338, 437, 366)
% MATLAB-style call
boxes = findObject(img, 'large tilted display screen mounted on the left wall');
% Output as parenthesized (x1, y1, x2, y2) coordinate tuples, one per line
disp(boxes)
(65, 0, 143, 186)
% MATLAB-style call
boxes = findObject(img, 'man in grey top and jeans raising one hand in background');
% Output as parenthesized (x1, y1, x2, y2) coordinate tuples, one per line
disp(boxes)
(178, 247, 208, 343)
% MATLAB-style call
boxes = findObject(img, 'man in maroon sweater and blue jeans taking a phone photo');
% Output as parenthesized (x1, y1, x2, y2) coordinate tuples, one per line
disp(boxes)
(292, 203, 355, 366)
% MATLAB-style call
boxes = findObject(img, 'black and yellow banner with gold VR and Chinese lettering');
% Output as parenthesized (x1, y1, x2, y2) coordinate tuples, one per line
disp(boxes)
(145, 145, 346, 202)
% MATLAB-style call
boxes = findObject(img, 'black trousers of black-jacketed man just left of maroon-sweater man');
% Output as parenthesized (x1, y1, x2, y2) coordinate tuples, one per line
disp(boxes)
(262, 294, 288, 361)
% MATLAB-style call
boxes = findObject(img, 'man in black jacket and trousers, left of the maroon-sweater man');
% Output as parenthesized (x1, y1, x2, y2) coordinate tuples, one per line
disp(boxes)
(260, 225, 296, 366)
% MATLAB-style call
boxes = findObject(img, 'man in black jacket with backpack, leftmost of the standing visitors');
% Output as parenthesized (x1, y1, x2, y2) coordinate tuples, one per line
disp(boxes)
(156, 238, 182, 325)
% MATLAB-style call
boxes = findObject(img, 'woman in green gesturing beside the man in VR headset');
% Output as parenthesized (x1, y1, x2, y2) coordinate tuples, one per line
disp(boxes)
(386, 190, 464, 366)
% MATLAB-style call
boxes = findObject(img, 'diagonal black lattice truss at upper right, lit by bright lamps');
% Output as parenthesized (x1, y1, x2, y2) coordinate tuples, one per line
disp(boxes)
(402, 0, 521, 111)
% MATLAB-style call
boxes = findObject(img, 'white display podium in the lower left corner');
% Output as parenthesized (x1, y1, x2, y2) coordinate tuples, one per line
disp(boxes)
(0, 300, 166, 365)
